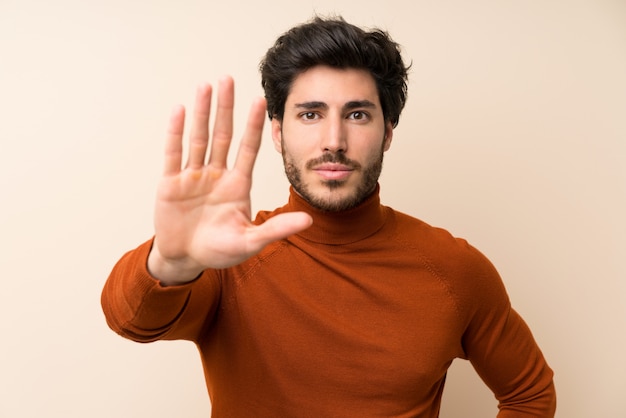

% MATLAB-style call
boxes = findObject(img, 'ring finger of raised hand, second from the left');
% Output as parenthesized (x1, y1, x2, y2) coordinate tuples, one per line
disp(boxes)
(187, 84, 212, 169)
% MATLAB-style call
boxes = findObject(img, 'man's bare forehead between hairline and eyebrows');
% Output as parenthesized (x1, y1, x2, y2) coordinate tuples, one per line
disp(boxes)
(285, 66, 380, 107)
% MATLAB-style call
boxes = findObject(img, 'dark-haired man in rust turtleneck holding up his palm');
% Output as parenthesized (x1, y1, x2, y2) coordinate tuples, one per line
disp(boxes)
(102, 18, 555, 418)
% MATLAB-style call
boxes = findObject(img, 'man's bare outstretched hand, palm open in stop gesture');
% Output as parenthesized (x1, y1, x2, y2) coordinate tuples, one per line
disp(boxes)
(148, 77, 311, 285)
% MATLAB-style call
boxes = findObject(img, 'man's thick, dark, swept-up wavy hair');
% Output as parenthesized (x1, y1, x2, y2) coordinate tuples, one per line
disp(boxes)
(260, 17, 410, 127)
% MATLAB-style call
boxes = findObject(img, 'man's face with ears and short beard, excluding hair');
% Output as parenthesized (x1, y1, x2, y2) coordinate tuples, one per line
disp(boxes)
(272, 66, 393, 211)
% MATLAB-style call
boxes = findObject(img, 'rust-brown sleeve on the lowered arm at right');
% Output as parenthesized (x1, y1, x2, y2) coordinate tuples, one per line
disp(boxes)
(454, 243, 556, 418)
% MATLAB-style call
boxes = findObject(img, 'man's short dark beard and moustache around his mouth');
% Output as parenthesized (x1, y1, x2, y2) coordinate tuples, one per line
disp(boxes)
(282, 143, 384, 212)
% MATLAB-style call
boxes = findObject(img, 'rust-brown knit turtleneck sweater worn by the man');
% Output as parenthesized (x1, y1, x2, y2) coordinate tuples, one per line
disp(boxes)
(102, 191, 556, 418)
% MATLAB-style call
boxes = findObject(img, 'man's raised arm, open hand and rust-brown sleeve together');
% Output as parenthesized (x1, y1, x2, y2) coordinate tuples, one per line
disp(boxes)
(102, 78, 311, 341)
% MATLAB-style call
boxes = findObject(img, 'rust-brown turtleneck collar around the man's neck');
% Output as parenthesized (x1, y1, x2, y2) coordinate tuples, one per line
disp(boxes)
(282, 185, 386, 245)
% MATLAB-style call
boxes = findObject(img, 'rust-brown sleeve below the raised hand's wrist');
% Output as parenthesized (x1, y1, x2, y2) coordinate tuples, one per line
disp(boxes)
(101, 240, 220, 342)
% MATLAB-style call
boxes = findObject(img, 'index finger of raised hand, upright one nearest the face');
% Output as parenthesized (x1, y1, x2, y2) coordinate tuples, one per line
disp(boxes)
(235, 98, 266, 177)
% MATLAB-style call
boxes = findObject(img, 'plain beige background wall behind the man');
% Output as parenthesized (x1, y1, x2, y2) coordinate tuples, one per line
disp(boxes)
(0, 0, 626, 418)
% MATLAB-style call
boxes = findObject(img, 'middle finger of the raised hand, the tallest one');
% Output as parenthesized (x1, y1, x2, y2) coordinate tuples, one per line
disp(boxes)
(209, 77, 235, 168)
